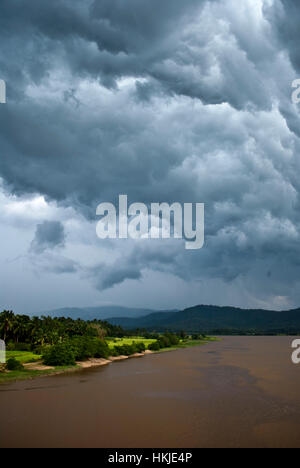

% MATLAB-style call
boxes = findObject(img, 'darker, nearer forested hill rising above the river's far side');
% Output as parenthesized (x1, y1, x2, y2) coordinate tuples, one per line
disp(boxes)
(108, 305, 300, 334)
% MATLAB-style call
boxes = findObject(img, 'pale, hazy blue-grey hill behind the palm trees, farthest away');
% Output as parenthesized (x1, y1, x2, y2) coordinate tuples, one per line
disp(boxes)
(39, 306, 176, 320)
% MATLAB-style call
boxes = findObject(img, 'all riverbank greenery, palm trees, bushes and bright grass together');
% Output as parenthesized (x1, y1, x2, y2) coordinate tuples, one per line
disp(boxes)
(0, 311, 216, 382)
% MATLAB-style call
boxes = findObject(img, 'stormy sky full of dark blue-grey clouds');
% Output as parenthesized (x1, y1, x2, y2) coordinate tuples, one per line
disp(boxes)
(0, 0, 300, 313)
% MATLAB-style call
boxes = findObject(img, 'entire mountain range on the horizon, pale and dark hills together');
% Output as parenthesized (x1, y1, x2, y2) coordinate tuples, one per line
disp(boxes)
(40, 305, 300, 334)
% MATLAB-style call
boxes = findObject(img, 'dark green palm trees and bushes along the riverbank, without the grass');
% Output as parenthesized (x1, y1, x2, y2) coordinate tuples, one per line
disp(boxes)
(0, 311, 204, 370)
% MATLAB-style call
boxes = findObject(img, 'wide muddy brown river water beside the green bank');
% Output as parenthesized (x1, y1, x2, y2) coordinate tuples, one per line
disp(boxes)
(0, 337, 300, 448)
